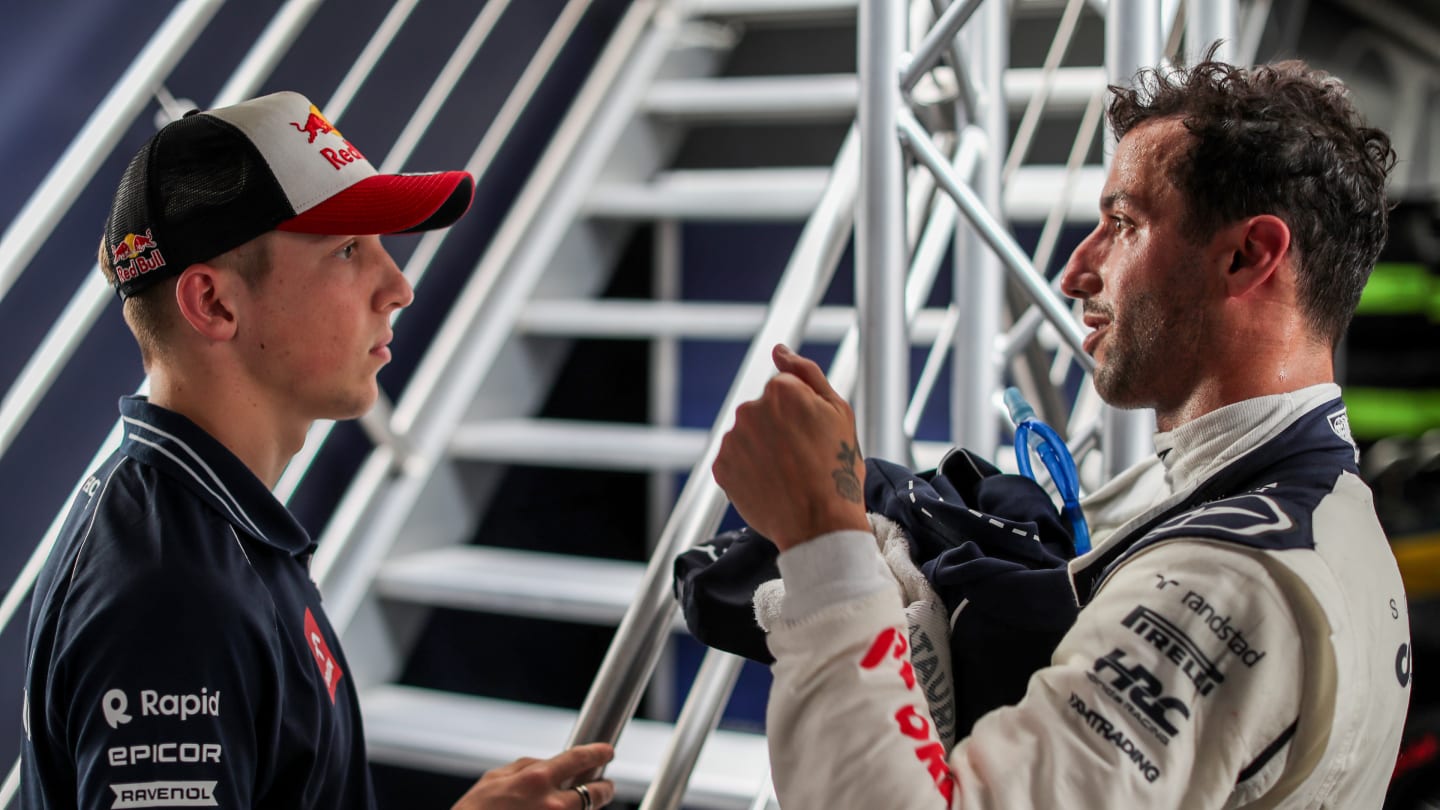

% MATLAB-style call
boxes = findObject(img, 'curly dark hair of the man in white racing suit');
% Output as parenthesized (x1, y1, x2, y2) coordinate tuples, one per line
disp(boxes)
(1109, 42, 1395, 347)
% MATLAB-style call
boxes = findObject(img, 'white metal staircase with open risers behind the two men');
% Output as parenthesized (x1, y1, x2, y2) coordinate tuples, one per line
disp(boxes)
(315, 0, 1134, 807)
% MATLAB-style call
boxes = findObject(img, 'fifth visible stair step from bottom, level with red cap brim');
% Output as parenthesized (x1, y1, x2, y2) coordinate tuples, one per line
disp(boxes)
(586, 166, 1104, 222)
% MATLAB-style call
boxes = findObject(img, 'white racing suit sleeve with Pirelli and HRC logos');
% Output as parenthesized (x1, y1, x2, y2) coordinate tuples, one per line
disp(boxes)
(766, 538, 1302, 810)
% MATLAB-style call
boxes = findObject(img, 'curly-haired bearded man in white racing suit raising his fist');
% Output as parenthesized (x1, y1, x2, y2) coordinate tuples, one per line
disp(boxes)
(714, 52, 1410, 810)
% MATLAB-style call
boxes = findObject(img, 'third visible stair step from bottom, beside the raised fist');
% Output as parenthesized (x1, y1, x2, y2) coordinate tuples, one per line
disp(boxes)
(449, 419, 708, 473)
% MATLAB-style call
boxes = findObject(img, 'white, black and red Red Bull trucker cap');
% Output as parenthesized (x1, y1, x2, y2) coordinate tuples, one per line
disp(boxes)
(105, 92, 475, 298)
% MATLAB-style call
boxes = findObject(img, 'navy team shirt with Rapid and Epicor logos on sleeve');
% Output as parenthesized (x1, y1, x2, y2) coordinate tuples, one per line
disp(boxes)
(20, 398, 374, 809)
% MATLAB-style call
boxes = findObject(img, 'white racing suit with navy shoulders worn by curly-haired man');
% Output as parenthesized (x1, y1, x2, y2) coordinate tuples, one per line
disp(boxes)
(768, 385, 1410, 810)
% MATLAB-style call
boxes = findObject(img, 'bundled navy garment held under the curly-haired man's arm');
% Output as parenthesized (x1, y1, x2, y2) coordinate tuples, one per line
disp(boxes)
(674, 448, 1080, 736)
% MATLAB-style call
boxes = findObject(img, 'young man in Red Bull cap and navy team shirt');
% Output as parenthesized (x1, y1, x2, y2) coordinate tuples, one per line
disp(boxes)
(22, 92, 613, 810)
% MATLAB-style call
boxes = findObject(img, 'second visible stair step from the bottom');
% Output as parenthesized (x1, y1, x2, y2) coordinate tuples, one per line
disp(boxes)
(376, 546, 684, 630)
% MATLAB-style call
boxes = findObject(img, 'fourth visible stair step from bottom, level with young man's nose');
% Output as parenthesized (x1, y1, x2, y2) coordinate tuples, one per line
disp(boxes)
(518, 298, 945, 344)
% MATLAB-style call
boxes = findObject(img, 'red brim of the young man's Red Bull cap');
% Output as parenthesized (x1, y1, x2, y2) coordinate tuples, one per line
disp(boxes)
(275, 172, 475, 235)
